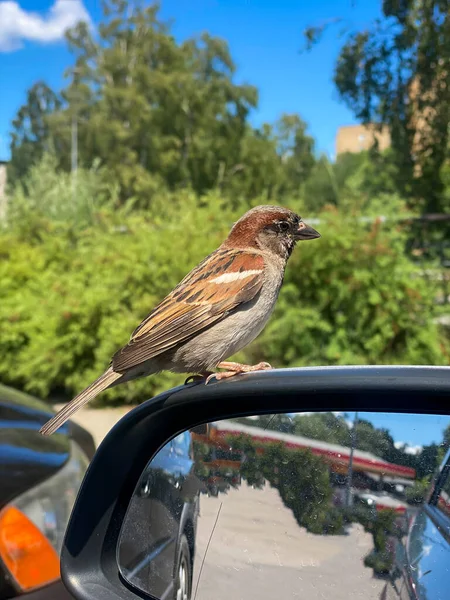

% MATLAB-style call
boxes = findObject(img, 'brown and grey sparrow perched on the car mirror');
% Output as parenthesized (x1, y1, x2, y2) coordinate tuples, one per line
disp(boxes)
(40, 206, 320, 435)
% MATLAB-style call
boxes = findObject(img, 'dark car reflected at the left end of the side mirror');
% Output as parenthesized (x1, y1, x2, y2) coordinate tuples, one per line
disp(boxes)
(118, 431, 202, 598)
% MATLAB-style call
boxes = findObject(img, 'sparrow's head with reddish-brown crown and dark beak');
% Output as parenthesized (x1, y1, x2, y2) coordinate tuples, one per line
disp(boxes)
(225, 206, 320, 259)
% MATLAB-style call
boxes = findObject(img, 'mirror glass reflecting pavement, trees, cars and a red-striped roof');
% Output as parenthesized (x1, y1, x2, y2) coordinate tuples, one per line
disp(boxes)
(118, 413, 450, 600)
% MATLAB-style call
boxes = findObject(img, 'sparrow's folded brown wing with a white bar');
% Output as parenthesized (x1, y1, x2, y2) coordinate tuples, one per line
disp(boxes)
(111, 249, 264, 373)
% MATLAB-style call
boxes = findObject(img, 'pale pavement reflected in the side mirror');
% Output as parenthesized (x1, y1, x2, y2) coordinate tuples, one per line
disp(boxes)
(193, 483, 384, 600)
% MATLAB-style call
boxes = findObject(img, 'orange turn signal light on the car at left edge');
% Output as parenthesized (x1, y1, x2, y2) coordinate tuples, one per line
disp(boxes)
(0, 506, 60, 591)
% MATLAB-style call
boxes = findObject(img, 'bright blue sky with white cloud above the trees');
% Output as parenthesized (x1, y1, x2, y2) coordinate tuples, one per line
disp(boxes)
(0, 0, 381, 159)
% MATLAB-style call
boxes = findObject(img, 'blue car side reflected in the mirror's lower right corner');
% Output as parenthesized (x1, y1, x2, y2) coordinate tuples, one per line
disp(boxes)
(381, 451, 450, 600)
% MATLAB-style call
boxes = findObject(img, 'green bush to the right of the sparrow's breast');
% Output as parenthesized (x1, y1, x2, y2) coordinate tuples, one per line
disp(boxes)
(249, 211, 448, 366)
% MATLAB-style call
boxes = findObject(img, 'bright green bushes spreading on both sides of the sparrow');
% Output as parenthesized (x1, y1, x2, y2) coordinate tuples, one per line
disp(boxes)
(0, 162, 448, 403)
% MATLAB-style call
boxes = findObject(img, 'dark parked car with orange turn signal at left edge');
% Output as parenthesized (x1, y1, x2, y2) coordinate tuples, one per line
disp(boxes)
(0, 385, 95, 600)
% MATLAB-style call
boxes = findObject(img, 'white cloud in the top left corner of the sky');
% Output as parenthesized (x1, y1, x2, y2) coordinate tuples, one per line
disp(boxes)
(0, 0, 90, 52)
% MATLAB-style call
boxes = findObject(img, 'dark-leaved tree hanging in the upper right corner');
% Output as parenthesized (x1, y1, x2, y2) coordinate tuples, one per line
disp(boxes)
(305, 0, 450, 212)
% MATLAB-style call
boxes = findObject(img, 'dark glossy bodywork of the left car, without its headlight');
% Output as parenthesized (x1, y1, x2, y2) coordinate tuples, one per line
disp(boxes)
(0, 385, 95, 600)
